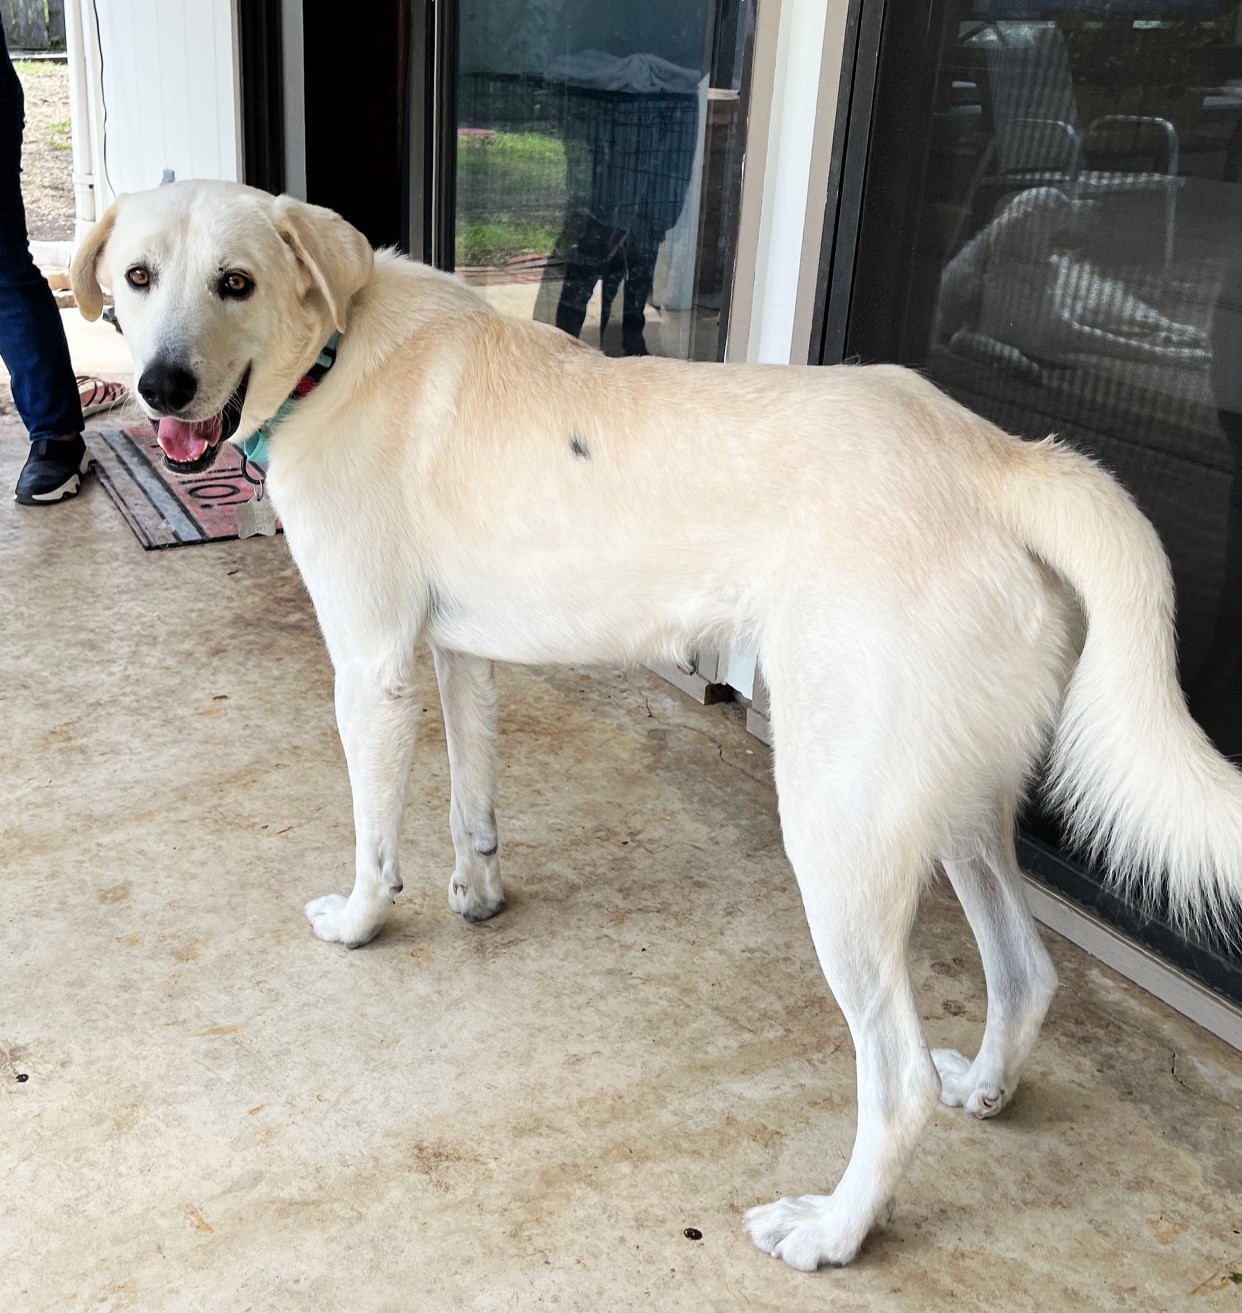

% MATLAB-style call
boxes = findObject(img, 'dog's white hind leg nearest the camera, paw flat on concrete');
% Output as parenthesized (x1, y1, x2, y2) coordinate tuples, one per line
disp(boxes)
(747, 651, 940, 1271)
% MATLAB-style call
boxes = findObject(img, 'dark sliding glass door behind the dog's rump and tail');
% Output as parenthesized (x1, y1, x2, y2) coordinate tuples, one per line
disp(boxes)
(823, 0, 1242, 998)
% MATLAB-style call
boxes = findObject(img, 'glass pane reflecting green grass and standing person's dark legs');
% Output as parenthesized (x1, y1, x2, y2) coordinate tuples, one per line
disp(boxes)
(456, 0, 748, 360)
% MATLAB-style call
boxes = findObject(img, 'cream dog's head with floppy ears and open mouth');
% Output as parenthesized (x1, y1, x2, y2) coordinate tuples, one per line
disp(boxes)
(71, 183, 373, 473)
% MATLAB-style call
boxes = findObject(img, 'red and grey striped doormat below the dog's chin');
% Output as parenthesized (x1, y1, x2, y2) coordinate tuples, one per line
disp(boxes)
(85, 427, 279, 551)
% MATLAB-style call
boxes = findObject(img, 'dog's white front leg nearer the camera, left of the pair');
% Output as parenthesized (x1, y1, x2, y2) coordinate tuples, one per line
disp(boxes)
(306, 662, 419, 948)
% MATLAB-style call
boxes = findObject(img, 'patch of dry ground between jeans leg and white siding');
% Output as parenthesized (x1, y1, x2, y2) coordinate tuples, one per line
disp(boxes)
(16, 59, 74, 242)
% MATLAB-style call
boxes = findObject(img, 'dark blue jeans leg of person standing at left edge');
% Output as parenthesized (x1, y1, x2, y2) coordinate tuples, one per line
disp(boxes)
(0, 26, 85, 441)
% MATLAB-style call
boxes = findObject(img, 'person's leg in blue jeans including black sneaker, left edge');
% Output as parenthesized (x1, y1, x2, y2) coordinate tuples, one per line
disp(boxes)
(0, 25, 91, 504)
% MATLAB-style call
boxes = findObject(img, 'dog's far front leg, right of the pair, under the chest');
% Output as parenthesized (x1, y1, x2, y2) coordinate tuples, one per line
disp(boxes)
(432, 647, 504, 920)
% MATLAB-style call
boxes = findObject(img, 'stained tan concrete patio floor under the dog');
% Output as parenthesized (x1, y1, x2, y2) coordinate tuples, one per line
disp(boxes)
(0, 366, 1242, 1313)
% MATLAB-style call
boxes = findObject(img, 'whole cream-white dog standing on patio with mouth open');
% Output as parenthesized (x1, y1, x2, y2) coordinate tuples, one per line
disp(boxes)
(72, 183, 1242, 1268)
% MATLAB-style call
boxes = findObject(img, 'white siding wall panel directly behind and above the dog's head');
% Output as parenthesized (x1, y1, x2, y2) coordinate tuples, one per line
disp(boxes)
(70, 0, 242, 222)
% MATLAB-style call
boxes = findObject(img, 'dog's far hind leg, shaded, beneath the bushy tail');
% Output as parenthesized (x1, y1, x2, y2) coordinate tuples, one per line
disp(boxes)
(932, 807, 1057, 1117)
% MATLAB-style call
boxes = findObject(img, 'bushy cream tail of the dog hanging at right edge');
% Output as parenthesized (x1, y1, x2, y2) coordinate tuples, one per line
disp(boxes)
(1000, 439, 1242, 934)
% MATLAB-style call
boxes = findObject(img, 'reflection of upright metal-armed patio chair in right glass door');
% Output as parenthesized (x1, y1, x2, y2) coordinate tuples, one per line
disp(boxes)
(970, 22, 1180, 265)
